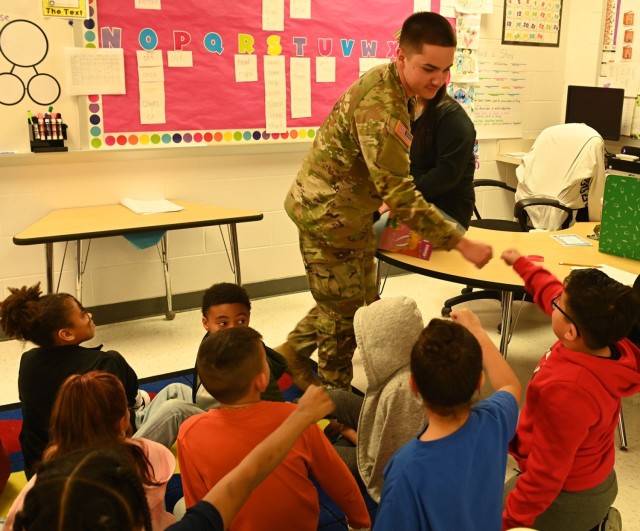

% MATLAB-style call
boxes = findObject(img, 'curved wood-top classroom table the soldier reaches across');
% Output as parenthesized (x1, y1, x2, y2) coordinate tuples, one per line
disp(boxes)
(377, 222, 640, 357)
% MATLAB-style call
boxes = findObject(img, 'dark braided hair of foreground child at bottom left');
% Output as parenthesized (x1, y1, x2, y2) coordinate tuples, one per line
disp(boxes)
(13, 446, 152, 531)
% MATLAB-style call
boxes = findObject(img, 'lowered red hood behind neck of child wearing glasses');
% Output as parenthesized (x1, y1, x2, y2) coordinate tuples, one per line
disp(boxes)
(557, 339, 640, 398)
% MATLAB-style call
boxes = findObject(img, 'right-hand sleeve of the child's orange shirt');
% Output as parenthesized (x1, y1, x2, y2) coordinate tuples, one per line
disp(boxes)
(305, 425, 371, 529)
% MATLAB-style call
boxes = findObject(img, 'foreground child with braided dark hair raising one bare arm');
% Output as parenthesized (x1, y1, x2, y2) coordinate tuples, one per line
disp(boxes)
(14, 387, 332, 531)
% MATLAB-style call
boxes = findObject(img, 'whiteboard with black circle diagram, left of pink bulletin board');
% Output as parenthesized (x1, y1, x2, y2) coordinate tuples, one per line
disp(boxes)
(0, 0, 82, 153)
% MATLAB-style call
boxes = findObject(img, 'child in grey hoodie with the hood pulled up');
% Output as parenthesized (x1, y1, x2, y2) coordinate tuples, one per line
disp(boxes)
(325, 297, 426, 502)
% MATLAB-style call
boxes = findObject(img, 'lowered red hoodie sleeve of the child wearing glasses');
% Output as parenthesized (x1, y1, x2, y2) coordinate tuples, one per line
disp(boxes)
(502, 382, 599, 529)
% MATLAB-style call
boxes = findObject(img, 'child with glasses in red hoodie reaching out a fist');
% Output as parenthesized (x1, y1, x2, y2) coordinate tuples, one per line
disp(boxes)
(502, 249, 640, 531)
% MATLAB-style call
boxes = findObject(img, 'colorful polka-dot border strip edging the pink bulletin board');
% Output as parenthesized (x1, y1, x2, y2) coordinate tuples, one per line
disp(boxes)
(83, 0, 318, 149)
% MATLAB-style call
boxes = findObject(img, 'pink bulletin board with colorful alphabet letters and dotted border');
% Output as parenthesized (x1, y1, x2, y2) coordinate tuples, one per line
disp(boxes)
(81, 0, 444, 149)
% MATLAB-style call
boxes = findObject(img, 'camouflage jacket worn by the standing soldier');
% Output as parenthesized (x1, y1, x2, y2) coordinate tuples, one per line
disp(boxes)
(285, 59, 461, 249)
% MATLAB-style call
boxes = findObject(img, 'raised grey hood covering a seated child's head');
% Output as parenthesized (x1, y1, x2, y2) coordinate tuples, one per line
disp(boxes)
(353, 297, 424, 392)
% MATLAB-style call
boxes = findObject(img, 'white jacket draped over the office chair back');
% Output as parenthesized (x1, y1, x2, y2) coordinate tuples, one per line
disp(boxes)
(516, 124, 605, 230)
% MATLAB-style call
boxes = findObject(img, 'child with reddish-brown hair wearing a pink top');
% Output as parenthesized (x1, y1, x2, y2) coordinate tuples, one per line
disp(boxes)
(4, 371, 176, 531)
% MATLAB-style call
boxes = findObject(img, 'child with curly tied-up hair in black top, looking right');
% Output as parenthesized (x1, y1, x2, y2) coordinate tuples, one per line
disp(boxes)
(0, 283, 138, 479)
